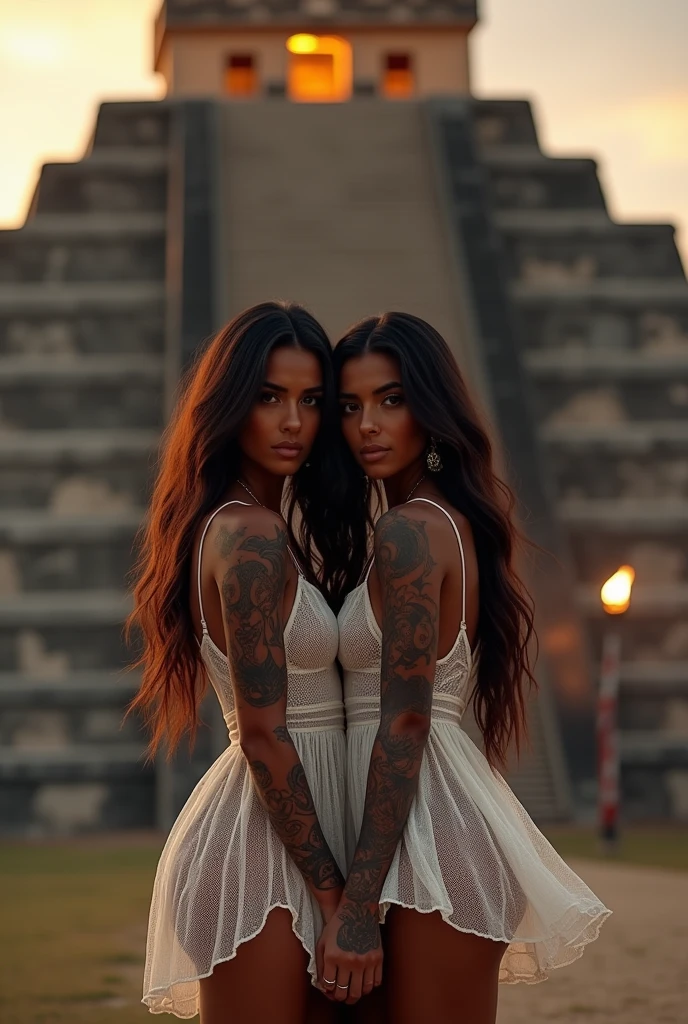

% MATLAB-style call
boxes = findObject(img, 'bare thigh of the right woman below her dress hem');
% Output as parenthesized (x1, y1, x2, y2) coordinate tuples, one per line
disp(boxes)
(385, 906, 507, 1024)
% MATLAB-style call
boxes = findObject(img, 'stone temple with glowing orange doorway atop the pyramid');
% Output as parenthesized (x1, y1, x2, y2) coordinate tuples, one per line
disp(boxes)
(155, 0, 477, 102)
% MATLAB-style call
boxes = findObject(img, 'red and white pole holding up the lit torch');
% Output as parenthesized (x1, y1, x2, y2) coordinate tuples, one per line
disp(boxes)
(597, 630, 621, 852)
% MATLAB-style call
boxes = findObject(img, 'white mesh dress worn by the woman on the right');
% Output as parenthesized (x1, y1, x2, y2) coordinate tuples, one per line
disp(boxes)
(339, 498, 610, 983)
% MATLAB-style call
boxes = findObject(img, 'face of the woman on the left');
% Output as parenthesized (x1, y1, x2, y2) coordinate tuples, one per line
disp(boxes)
(239, 348, 323, 476)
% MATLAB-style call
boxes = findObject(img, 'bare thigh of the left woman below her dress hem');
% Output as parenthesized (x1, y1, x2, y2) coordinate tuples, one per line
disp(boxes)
(201, 908, 311, 1024)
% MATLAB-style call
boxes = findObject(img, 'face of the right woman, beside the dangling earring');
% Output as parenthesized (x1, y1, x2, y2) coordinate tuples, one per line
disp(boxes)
(339, 352, 427, 480)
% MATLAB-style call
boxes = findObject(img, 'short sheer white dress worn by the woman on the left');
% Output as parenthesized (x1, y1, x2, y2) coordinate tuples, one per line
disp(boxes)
(142, 502, 346, 1021)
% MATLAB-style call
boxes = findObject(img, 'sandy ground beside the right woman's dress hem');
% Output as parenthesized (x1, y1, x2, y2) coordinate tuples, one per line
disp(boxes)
(498, 861, 688, 1024)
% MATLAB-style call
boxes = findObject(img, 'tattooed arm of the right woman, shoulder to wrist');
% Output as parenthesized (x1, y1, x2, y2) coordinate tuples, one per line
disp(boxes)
(337, 511, 438, 953)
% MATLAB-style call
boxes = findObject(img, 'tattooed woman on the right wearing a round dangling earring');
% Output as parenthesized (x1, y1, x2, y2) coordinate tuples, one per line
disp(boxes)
(318, 313, 608, 1024)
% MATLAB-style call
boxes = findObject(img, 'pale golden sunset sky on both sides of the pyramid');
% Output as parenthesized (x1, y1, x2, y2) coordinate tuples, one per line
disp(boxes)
(0, 0, 688, 266)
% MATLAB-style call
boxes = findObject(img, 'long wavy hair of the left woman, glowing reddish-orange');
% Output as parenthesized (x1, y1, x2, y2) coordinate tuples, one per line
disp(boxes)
(127, 302, 345, 754)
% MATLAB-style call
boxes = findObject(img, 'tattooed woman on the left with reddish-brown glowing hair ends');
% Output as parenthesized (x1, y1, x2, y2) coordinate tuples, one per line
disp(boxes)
(132, 303, 345, 1024)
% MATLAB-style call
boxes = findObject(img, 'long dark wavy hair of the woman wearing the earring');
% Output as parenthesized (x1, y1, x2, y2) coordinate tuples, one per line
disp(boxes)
(335, 312, 536, 766)
